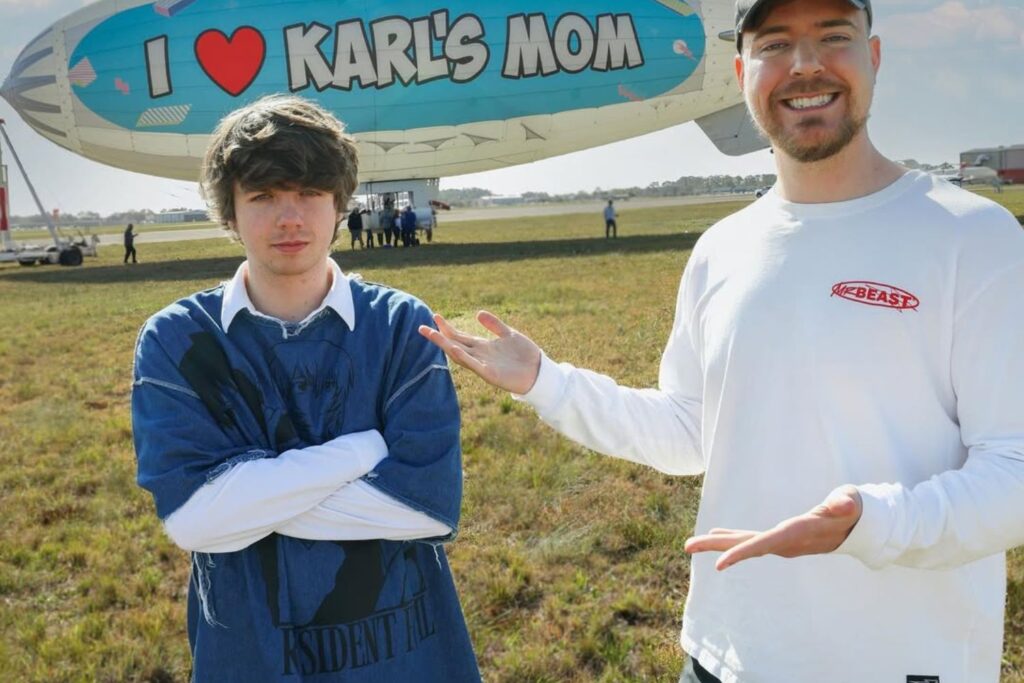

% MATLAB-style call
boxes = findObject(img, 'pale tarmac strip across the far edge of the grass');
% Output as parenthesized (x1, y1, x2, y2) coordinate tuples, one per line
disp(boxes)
(119, 194, 754, 248)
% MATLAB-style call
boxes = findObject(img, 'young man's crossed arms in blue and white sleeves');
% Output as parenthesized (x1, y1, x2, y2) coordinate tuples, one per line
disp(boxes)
(132, 321, 461, 552)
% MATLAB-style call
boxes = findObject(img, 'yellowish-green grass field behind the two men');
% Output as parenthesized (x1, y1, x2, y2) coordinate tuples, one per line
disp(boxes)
(0, 189, 1024, 683)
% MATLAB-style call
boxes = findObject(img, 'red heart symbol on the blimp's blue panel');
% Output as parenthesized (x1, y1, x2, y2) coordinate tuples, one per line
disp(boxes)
(196, 26, 266, 97)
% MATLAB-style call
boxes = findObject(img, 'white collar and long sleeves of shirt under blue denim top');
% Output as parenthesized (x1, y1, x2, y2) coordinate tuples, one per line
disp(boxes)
(164, 259, 452, 553)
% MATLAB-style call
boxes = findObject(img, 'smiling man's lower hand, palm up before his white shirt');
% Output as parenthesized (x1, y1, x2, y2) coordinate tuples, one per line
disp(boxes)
(684, 485, 863, 571)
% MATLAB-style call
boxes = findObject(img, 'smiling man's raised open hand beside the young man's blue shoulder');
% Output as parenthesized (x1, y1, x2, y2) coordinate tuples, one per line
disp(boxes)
(420, 310, 541, 394)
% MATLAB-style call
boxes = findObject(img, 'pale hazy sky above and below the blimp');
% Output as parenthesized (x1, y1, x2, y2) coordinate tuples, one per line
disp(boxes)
(0, 0, 1024, 214)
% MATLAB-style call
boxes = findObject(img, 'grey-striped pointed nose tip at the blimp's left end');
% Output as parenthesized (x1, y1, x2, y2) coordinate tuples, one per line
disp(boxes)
(0, 30, 68, 146)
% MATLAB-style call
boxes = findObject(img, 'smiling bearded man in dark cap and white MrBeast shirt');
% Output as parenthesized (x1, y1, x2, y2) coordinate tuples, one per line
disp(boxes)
(421, 0, 1024, 683)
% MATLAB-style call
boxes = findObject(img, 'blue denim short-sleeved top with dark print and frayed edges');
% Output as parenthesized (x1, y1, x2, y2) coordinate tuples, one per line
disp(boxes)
(132, 280, 479, 683)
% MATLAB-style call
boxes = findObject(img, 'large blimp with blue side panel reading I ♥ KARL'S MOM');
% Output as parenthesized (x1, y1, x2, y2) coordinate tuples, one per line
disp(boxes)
(0, 0, 766, 201)
